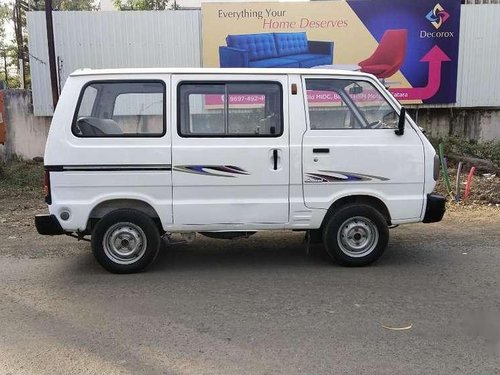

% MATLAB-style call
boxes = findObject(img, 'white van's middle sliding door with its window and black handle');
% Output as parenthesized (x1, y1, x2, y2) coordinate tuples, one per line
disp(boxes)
(172, 74, 289, 225)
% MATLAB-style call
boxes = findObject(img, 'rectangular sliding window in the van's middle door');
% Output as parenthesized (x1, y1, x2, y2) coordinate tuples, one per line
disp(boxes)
(178, 82, 283, 137)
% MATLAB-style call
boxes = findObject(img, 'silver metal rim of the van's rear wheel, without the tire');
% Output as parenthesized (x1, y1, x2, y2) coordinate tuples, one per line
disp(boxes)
(102, 223, 147, 264)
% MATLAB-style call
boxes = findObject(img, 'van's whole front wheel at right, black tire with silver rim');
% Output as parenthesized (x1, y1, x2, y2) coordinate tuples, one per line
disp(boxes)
(323, 204, 389, 267)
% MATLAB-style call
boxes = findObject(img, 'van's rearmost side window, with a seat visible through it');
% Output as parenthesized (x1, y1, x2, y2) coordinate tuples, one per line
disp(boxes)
(72, 81, 165, 137)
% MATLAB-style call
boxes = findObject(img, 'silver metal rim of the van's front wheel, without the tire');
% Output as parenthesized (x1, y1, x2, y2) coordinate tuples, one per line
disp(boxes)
(337, 216, 379, 258)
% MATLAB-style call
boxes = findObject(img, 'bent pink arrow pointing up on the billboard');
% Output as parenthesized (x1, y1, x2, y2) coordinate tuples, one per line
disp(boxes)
(389, 45, 451, 100)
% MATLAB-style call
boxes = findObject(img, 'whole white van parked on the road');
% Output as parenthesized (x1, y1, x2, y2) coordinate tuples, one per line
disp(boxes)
(35, 69, 445, 273)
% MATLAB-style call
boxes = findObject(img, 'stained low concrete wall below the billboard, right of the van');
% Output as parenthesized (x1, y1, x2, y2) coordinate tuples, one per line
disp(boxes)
(410, 108, 500, 141)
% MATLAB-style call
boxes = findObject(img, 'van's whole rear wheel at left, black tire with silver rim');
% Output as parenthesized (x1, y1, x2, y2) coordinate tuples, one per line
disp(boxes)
(91, 209, 160, 273)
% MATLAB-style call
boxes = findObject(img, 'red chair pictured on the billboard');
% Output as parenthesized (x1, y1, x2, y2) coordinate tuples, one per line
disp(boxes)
(358, 29, 408, 80)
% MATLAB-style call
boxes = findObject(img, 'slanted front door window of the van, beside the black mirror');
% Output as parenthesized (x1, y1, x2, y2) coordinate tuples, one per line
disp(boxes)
(306, 79, 398, 130)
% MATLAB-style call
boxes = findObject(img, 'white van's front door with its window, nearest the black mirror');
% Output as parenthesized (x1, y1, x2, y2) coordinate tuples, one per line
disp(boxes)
(303, 76, 424, 222)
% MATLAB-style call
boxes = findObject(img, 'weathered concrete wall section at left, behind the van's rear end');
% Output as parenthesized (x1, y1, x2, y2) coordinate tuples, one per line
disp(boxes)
(0, 90, 51, 160)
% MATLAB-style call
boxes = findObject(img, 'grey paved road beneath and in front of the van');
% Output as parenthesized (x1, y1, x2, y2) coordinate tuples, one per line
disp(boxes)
(0, 210, 500, 375)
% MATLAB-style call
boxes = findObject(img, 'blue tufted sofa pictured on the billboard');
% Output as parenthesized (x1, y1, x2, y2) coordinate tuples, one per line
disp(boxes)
(219, 32, 333, 68)
